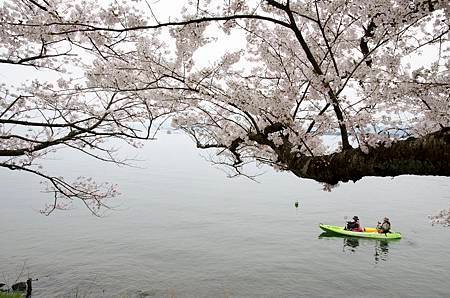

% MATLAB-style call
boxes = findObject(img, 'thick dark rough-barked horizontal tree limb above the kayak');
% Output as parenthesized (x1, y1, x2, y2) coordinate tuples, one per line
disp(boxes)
(280, 128, 450, 184)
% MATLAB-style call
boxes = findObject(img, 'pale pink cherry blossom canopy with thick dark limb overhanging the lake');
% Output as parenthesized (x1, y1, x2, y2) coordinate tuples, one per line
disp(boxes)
(0, 0, 450, 219)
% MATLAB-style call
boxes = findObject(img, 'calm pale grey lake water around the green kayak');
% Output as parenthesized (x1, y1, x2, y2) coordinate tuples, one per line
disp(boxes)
(0, 134, 450, 297)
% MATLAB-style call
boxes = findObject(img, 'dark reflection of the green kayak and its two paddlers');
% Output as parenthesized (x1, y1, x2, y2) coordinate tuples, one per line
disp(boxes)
(319, 232, 399, 264)
